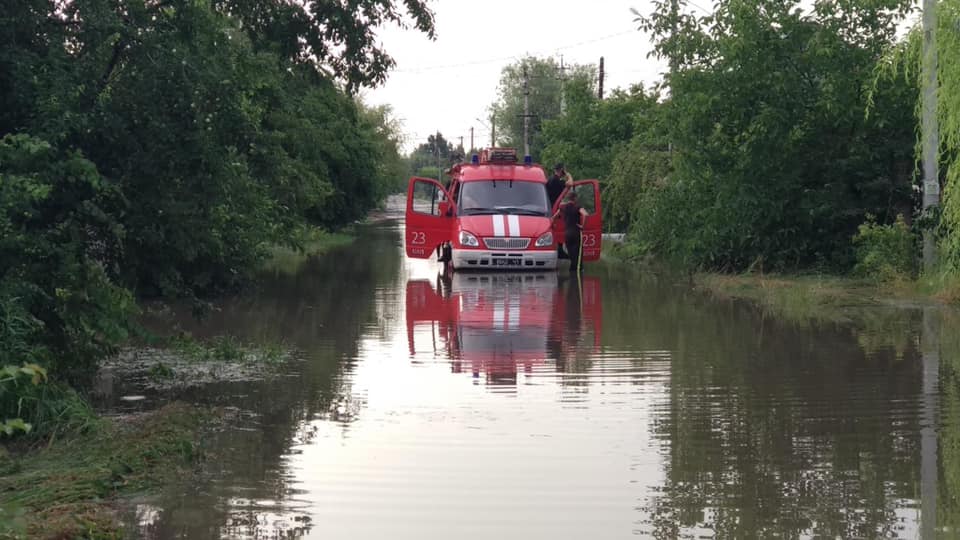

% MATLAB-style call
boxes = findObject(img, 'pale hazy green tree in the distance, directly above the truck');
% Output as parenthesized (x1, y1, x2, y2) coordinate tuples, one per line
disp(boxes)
(491, 56, 596, 161)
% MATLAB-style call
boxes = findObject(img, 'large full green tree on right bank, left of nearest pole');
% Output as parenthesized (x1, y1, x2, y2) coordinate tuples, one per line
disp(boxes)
(635, 0, 914, 269)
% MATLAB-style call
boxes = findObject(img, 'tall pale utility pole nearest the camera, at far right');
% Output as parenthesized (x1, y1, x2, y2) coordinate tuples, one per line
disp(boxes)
(920, 0, 940, 273)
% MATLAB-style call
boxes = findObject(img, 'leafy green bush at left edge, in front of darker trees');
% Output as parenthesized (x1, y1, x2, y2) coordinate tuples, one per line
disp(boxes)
(0, 135, 136, 383)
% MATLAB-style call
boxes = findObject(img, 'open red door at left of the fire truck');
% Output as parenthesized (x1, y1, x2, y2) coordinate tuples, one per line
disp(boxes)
(404, 177, 454, 259)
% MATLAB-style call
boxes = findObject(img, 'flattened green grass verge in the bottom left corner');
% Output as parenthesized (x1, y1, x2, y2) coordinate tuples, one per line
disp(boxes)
(0, 404, 214, 539)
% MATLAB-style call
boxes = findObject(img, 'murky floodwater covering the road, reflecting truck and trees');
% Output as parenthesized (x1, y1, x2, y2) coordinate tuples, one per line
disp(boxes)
(114, 205, 960, 540)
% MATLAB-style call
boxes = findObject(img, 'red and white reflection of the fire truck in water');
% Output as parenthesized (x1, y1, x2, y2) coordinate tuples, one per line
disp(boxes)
(406, 272, 603, 384)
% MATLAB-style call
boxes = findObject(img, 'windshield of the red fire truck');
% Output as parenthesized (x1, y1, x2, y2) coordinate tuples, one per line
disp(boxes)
(459, 180, 550, 216)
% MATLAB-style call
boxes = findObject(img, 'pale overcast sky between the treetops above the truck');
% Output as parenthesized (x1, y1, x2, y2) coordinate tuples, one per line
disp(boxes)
(364, 0, 668, 150)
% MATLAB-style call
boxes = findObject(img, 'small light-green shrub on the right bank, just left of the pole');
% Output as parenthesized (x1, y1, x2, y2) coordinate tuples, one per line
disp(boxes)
(853, 215, 916, 282)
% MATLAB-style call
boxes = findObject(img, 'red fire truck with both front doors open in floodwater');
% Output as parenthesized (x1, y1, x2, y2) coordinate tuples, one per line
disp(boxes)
(404, 148, 603, 270)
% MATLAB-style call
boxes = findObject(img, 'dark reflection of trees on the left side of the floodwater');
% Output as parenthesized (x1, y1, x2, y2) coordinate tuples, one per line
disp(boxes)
(129, 221, 401, 538)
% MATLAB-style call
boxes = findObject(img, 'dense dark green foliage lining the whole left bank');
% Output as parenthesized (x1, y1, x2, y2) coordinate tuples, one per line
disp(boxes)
(0, 0, 433, 419)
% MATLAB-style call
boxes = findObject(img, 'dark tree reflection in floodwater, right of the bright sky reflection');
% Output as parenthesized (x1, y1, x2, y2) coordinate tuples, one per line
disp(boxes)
(604, 268, 921, 538)
